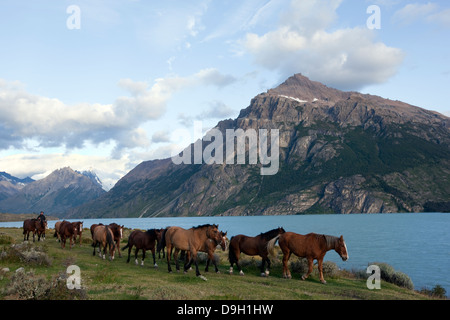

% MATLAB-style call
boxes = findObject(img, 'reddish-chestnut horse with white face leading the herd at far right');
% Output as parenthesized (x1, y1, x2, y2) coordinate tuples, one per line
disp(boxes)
(268, 232, 349, 284)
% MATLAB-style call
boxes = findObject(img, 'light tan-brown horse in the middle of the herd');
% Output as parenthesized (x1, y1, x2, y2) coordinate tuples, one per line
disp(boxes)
(163, 224, 220, 277)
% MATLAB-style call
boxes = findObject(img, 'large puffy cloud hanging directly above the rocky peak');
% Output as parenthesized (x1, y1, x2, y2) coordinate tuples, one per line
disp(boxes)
(240, 0, 404, 90)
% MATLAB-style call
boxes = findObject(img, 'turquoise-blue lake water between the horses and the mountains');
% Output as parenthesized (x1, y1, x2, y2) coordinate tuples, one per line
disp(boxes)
(0, 213, 450, 295)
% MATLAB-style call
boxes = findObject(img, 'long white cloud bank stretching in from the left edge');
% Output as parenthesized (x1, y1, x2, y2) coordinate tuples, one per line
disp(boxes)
(0, 68, 235, 157)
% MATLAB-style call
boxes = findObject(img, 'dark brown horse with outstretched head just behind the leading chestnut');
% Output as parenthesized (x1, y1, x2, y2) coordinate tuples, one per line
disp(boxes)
(228, 227, 285, 277)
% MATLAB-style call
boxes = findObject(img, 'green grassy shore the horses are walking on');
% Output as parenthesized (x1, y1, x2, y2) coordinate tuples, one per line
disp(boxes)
(0, 228, 442, 300)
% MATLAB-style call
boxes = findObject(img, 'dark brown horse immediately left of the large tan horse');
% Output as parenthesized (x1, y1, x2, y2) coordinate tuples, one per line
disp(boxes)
(122, 229, 161, 268)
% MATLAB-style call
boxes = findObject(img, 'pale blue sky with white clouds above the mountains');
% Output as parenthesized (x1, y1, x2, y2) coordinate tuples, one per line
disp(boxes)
(0, 0, 450, 189)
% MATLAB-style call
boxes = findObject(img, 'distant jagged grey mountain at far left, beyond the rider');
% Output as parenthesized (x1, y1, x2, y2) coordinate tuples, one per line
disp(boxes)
(0, 167, 105, 216)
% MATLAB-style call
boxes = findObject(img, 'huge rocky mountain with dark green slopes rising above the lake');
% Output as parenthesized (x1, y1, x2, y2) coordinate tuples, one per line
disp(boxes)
(69, 74, 450, 217)
